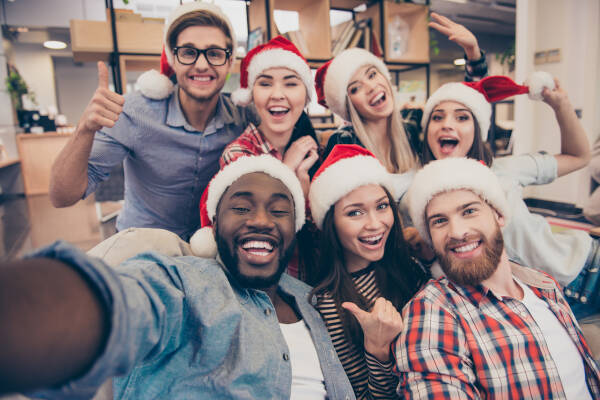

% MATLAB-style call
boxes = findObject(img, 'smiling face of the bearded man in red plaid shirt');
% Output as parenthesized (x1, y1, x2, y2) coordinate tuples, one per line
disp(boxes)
(425, 190, 504, 286)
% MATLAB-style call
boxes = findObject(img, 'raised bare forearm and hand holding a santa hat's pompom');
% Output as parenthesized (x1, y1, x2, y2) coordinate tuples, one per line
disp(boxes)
(542, 78, 591, 177)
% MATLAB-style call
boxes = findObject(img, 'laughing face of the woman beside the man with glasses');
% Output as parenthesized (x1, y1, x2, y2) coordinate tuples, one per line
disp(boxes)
(252, 68, 307, 141)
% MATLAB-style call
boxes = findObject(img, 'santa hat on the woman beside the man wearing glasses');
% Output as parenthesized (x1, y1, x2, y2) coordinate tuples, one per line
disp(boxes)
(231, 36, 313, 106)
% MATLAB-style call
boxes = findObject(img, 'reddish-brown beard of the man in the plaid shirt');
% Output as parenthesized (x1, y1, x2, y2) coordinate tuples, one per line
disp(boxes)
(438, 225, 504, 286)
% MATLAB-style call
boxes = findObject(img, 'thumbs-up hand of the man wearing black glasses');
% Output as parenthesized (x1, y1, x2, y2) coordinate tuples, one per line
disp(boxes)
(79, 61, 125, 134)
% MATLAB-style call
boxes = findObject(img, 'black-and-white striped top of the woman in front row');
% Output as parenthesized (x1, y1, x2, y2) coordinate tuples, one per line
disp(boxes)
(316, 265, 398, 399)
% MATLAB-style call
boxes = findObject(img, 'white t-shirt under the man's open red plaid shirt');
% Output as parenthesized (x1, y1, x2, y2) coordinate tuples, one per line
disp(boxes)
(515, 279, 592, 400)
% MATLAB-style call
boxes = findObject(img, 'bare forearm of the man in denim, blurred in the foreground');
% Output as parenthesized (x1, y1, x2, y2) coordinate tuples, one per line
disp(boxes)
(0, 258, 109, 394)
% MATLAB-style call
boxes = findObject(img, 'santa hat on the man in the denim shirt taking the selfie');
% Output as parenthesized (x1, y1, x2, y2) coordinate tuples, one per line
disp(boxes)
(190, 154, 306, 258)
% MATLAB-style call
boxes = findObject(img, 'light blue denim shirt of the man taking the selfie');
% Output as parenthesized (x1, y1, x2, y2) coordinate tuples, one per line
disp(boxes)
(29, 242, 355, 400)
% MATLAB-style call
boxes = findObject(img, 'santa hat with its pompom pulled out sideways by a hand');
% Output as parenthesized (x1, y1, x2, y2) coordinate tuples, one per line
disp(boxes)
(421, 71, 555, 142)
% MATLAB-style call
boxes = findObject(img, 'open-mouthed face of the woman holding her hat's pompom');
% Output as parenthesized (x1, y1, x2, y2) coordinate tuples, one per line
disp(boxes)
(426, 101, 475, 160)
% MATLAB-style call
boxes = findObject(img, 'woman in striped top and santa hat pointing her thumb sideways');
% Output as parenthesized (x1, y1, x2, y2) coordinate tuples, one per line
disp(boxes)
(308, 145, 428, 399)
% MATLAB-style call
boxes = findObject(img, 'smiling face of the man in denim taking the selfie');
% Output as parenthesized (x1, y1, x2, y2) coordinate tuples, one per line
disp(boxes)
(215, 172, 295, 289)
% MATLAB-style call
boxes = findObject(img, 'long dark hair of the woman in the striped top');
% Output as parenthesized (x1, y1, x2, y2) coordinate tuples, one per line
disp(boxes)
(309, 188, 429, 348)
